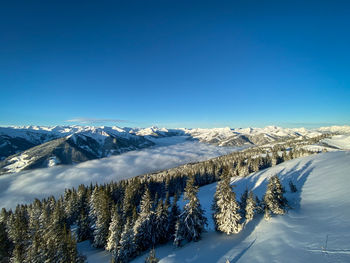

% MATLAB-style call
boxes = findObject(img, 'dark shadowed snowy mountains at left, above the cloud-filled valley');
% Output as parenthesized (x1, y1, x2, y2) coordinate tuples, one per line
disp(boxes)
(0, 126, 154, 174)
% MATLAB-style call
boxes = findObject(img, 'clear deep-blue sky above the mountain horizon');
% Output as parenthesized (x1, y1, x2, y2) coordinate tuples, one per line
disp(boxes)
(0, 0, 350, 127)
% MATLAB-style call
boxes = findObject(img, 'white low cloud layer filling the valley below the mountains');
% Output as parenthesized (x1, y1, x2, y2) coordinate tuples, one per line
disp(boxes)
(0, 141, 241, 208)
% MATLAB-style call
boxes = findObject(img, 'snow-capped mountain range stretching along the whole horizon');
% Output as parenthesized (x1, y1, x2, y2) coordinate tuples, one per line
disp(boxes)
(0, 126, 350, 174)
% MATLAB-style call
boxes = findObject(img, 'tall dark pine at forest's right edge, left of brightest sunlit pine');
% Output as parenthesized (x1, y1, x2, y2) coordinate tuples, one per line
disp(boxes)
(174, 176, 207, 246)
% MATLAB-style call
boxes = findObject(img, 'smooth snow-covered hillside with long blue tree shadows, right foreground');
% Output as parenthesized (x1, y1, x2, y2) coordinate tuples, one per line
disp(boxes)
(79, 137, 350, 263)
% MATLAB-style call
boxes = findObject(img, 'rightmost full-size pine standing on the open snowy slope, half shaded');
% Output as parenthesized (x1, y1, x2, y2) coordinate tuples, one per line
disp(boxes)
(264, 175, 287, 219)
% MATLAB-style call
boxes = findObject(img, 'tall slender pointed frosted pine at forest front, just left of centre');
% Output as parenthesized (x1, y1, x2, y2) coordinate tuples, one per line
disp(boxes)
(134, 188, 156, 251)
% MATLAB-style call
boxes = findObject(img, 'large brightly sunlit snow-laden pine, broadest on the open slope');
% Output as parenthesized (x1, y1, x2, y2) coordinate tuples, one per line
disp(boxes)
(214, 176, 242, 234)
